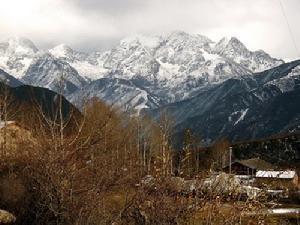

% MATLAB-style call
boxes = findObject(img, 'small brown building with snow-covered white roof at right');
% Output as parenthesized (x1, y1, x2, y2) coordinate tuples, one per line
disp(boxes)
(255, 170, 299, 189)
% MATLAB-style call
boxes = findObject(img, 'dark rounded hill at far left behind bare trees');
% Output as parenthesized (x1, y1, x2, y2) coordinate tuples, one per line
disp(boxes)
(0, 83, 81, 132)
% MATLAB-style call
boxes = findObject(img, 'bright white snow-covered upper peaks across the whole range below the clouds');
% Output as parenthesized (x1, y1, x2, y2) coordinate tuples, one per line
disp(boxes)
(0, 31, 283, 86)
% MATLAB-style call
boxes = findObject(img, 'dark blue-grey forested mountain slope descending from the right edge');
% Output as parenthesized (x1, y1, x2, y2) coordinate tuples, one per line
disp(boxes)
(150, 60, 300, 143)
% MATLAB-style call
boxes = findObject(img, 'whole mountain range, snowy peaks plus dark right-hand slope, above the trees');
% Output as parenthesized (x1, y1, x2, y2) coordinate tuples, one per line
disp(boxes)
(0, 32, 300, 143)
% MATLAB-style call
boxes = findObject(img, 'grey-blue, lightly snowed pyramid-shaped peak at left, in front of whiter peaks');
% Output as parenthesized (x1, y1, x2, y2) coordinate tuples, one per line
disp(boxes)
(22, 53, 86, 95)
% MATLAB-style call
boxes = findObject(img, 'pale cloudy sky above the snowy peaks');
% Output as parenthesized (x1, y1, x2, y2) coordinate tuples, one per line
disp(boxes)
(0, 0, 300, 59)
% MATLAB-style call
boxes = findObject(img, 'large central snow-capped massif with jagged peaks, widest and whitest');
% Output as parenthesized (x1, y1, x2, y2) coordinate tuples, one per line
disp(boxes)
(104, 32, 283, 86)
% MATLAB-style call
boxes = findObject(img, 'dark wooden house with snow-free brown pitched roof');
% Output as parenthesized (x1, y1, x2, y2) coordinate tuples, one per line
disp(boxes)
(223, 158, 274, 176)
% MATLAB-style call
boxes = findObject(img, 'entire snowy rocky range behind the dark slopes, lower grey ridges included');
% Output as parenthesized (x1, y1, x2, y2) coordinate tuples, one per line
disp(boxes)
(0, 32, 283, 111)
